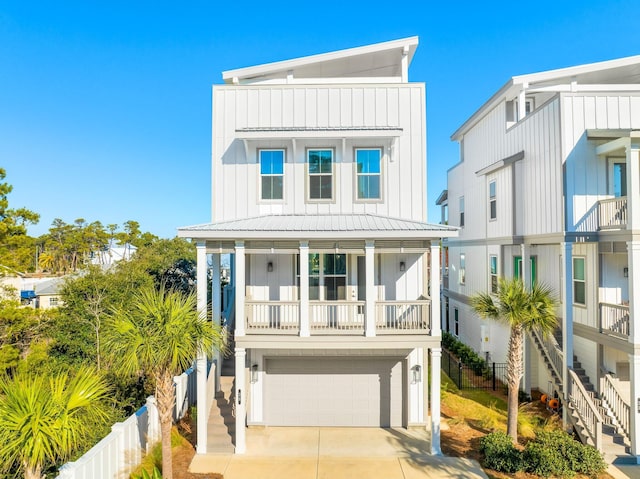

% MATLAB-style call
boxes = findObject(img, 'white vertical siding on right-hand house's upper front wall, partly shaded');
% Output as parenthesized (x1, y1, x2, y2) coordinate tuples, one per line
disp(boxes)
(562, 93, 640, 231)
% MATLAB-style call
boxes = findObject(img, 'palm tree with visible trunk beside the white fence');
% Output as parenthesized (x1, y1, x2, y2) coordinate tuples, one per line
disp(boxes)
(104, 287, 224, 479)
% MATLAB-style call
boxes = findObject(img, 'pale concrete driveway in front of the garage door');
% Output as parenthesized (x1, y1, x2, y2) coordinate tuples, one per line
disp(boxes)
(190, 427, 487, 479)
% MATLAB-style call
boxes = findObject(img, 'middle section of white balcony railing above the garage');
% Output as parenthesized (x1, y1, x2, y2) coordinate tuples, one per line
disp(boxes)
(309, 301, 365, 334)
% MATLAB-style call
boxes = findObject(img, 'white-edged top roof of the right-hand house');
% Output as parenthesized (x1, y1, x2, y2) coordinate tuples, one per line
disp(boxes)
(451, 55, 640, 141)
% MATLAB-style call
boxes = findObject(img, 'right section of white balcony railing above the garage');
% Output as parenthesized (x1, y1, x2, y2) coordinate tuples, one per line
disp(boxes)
(376, 300, 431, 334)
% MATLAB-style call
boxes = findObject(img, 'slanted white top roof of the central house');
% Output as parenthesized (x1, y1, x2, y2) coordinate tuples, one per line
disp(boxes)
(222, 37, 418, 83)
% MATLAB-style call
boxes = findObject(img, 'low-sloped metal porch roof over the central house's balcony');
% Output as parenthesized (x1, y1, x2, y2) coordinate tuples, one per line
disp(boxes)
(178, 214, 458, 239)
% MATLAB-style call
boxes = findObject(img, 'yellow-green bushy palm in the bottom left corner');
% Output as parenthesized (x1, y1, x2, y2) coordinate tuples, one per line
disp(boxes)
(0, 369, 109, 479)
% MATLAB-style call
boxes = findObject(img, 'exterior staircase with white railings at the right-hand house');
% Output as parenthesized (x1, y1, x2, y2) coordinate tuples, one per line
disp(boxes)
(531, 333, 635, 464)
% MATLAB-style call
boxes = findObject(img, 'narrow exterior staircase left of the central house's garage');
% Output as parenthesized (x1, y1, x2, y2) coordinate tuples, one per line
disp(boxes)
(207, 345, 236, 454)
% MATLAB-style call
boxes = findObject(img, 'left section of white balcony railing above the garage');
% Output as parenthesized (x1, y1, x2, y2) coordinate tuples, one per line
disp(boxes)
(245, 300, 300, 334)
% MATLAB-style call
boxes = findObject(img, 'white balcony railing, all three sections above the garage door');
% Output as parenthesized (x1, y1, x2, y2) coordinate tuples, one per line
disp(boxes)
(245, 299, 431, 336)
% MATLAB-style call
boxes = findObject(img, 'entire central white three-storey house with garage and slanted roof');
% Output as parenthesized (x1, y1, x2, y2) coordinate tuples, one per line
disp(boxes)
(179, 37, 456, 454)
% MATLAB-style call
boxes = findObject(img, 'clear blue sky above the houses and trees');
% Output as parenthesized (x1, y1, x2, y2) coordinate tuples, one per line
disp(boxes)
(0, 0, 640, 237)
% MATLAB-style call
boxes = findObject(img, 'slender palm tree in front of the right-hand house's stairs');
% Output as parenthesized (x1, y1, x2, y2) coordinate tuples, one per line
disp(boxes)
(471, 278, 557, 443)
